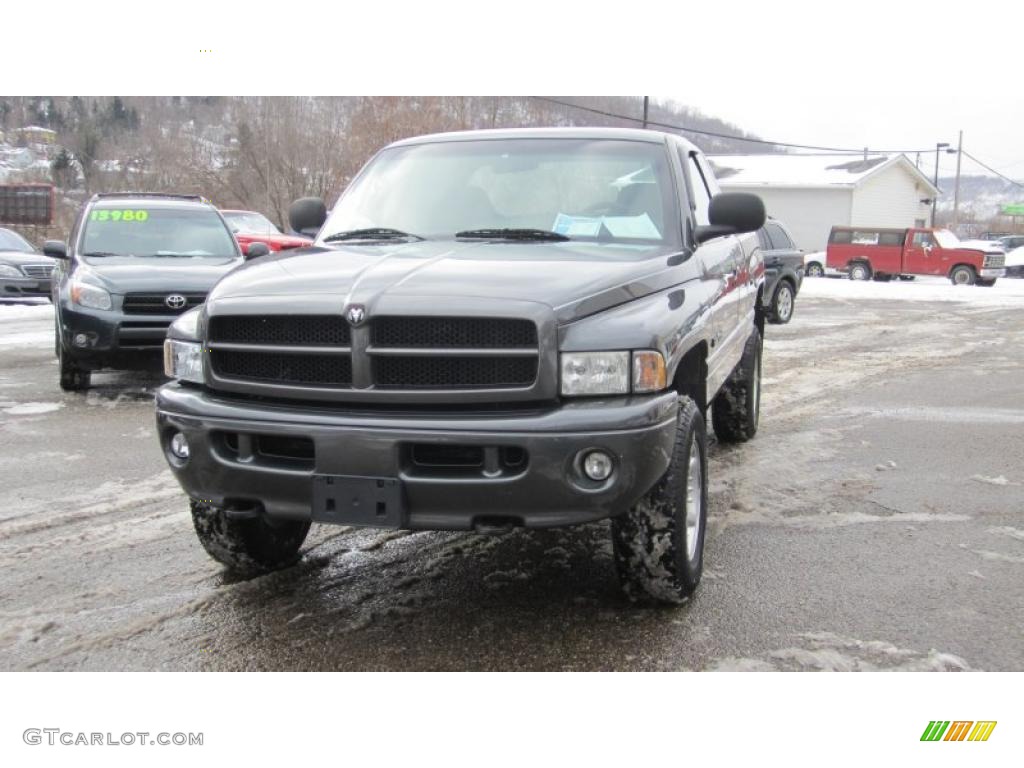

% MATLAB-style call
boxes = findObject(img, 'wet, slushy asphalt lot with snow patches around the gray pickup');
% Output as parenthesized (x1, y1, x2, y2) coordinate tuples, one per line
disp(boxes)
(0, 286, 1024, 671)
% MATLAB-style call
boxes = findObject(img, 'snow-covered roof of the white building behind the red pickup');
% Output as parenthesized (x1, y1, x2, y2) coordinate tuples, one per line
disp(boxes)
(709, 155, 938, 194)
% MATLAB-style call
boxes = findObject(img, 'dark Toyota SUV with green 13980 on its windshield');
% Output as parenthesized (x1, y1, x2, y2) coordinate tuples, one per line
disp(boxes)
(43, 193, 253, 390)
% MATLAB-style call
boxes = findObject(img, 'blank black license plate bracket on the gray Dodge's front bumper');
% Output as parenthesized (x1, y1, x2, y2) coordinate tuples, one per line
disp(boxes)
(312, 475, 406, 528)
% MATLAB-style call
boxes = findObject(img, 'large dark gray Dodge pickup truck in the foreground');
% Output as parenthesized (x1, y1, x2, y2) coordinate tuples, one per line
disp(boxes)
(157, 128, 765, 603)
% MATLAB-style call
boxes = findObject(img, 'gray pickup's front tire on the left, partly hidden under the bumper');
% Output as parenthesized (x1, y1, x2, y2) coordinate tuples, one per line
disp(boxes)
(189, 501, 309, 577)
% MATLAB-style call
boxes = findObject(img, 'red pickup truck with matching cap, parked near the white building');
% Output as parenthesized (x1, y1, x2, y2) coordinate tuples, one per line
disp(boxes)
(825, 226, 1006, 286)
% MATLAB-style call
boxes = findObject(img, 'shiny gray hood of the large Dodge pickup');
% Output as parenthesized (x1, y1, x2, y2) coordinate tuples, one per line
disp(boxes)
(203, 241, 697, 322)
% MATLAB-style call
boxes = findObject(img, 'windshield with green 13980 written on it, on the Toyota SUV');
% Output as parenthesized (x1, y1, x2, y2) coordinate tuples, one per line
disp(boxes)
(79, 207, 238, 258)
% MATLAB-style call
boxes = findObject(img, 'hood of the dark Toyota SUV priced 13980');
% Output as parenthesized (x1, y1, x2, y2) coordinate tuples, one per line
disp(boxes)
(75, 256, 242, 294)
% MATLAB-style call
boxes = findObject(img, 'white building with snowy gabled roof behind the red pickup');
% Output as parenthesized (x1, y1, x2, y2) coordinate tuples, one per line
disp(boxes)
(710, 155, 938, 251)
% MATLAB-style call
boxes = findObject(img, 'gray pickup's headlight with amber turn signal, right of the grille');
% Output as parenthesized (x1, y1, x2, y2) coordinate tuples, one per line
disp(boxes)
(560, 350, 666, 396)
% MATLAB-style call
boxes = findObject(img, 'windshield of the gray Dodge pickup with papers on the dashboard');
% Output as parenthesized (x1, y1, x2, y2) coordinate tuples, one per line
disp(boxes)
(321, 138, 680, 245)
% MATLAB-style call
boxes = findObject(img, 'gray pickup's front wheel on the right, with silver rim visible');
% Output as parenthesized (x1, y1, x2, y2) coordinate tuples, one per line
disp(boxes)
(611, 395, 708, 604)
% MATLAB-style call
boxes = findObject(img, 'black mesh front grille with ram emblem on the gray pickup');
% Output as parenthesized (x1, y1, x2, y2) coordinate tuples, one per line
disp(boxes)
(208, 314, 540, 395)
